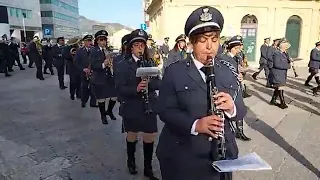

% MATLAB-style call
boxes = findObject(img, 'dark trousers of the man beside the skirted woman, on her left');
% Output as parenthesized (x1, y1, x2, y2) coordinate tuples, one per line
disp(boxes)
(81, 77, 96, 106)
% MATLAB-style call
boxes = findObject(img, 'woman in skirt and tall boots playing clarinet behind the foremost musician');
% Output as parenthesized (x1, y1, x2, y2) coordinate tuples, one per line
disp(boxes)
(116, 29, 159, 180)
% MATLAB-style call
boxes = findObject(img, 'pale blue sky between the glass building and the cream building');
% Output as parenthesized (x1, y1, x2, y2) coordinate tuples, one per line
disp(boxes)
(79, 0, 144, 28)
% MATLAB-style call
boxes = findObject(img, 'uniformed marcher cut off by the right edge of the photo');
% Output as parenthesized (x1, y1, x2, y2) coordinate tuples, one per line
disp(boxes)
(304, 41, 320, 87)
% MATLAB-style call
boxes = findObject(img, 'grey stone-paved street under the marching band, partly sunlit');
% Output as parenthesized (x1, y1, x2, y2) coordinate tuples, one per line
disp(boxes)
(0, 68, 320, 180)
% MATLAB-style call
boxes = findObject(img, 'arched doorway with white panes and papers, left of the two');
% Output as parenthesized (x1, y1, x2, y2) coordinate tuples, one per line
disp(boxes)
(241, 14, 258, 62)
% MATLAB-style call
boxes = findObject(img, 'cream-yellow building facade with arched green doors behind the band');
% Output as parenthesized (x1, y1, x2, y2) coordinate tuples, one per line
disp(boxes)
(144, 0, 320, 66)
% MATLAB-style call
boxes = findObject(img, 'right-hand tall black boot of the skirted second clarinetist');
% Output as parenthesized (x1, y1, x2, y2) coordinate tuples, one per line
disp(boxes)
(143, 142, 159, 180)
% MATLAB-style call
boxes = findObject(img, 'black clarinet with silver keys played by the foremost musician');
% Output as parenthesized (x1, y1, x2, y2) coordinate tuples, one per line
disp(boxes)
(205, 56, 226, 161)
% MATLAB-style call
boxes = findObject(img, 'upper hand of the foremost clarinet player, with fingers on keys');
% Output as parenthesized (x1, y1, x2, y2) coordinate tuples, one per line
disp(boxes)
(213, 92, 234, 114)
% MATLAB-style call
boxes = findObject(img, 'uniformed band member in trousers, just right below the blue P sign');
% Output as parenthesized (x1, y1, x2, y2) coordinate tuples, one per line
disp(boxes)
(52, 37, 67, 90)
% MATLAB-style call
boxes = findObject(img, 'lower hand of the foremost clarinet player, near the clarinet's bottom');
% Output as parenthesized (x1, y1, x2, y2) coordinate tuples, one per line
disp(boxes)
(195, 115, 224, 138)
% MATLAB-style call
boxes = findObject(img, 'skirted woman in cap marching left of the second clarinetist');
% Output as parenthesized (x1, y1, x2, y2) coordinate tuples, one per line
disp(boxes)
(89, 30, 117, 124)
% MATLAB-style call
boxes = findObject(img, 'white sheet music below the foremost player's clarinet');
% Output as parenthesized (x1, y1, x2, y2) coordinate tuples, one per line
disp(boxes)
(212, 152, 272, 172)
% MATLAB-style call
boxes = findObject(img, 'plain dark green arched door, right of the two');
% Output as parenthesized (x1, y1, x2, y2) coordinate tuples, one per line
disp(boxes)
(286, 15, 302, 58)
